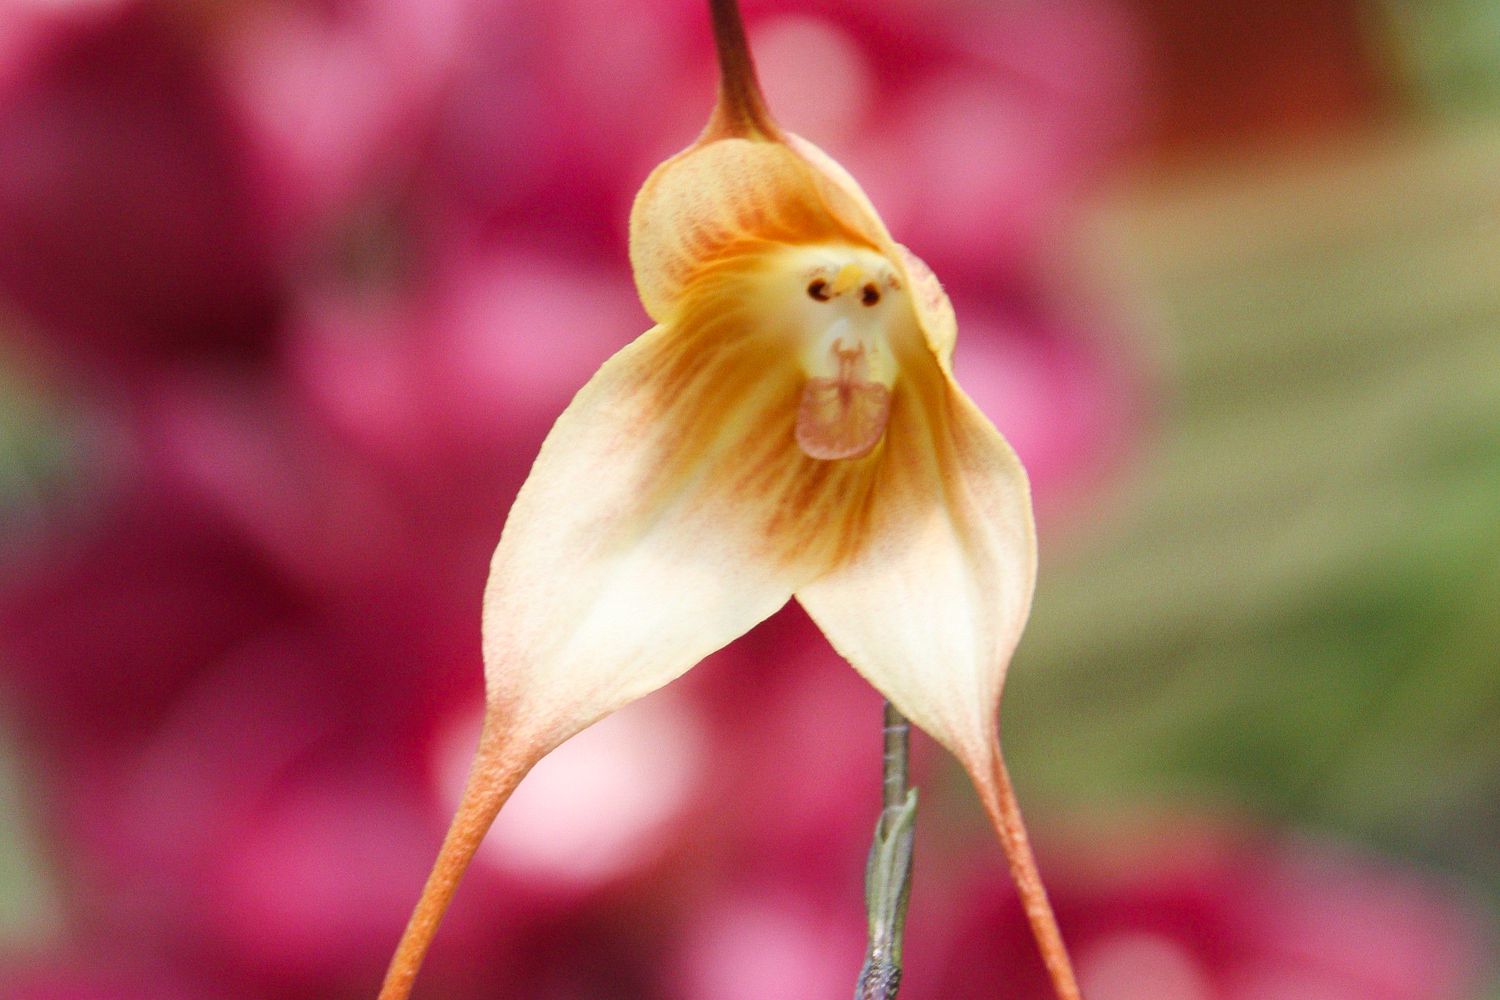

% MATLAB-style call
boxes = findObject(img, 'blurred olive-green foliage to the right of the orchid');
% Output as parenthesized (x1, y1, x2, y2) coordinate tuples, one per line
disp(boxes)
(1005, 127, 1500, 904)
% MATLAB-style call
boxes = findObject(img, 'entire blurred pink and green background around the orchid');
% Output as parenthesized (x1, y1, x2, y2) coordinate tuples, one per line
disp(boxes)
(0, 0, 1500, 1000)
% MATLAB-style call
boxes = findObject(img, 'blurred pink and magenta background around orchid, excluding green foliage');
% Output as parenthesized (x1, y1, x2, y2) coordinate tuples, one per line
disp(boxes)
(0, 0, 1491, 1000)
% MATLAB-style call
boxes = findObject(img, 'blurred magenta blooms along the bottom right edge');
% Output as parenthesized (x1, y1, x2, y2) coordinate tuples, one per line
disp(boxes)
(903, 820, 1493, 1000)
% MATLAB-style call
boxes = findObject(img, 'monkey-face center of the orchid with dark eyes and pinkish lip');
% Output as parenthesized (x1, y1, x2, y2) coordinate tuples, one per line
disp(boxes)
(789, 247, 911, 460)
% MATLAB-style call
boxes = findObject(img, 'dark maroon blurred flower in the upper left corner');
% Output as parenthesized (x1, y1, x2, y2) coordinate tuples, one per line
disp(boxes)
(0, 4, 284, 378)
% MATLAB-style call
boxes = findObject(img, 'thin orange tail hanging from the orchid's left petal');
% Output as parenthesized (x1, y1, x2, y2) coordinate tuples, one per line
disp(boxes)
(380, 715, 536, 1000)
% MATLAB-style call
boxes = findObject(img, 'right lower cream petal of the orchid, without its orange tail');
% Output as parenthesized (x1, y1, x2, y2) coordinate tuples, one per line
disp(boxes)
(797, 352, 1037, 774)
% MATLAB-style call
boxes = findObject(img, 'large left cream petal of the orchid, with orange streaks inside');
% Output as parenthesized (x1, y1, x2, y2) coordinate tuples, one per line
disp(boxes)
(483, 295, 888, 750)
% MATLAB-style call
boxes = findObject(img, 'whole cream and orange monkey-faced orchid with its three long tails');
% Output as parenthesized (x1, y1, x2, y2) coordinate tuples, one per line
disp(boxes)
(380, 0, 1079, 1000)
